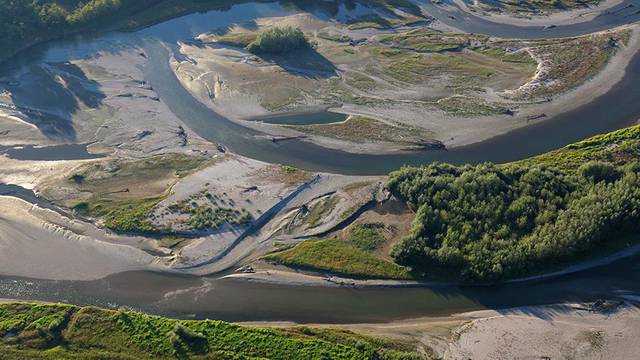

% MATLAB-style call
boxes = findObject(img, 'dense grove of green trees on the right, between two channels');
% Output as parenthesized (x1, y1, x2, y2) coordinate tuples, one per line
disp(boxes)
(388, 162, 640, 281)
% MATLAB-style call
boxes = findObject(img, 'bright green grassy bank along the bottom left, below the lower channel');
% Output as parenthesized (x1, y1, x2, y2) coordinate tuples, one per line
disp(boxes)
(0, 303, 421, 360)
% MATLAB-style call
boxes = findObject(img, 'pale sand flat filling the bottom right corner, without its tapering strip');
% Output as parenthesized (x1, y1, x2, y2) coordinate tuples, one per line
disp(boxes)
(443, 306, 640, 360)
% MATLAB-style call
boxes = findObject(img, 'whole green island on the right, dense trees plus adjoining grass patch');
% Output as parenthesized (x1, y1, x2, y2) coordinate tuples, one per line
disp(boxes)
(266, 126, 640, 282)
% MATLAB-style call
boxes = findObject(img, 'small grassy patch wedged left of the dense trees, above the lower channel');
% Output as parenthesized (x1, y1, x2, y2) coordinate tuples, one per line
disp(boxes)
(265, 239, 411, 279)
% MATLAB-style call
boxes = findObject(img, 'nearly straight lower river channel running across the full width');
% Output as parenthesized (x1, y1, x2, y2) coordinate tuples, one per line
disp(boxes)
(0, 253, 640, 323)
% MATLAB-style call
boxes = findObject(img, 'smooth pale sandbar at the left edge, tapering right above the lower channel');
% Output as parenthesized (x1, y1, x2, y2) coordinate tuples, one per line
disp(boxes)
(0, 196, 164, 280)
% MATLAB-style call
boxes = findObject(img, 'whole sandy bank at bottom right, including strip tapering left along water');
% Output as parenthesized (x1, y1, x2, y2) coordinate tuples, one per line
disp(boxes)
(243, 302, 640, 360)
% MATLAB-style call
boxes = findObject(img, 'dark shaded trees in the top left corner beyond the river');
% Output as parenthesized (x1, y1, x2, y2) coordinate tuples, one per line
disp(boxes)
(0, 0, 160, 59)
